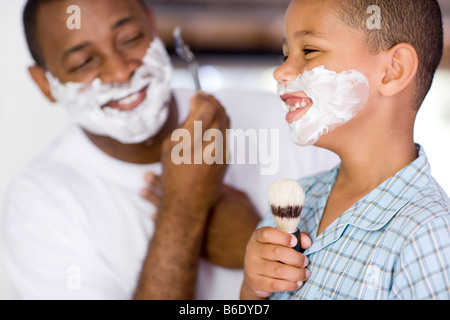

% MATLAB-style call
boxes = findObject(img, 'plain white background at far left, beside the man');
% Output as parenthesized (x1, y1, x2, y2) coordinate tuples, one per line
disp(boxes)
(0, 0, 68, 299)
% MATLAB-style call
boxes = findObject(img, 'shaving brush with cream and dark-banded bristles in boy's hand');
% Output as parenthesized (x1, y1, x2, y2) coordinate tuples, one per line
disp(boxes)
(268, 179, 305, 251)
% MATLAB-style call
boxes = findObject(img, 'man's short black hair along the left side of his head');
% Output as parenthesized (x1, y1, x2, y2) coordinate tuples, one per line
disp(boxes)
(23, 0, 149, 68)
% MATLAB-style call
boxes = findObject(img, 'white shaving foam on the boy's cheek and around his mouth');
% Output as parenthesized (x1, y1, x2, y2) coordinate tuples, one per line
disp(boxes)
(278, 66, 369, 146)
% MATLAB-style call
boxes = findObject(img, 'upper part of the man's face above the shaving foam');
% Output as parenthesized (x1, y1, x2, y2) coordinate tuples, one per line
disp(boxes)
(37, 0, 156, 83)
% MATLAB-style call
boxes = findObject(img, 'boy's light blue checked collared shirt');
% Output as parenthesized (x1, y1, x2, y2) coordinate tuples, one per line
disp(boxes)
(260, 146, 450, 300)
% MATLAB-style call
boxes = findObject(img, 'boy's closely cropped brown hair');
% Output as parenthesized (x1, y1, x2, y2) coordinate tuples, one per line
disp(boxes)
(335, 0, 444, 108)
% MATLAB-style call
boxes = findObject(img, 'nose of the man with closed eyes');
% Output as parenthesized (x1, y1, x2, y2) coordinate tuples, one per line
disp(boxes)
(100, 54, 139, 83)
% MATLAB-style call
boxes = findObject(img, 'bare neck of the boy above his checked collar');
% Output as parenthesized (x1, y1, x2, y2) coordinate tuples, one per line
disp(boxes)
(334, 97, 418, 191)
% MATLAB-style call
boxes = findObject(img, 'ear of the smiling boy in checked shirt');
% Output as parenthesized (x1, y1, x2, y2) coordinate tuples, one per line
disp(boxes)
(380, 43, 419, 96)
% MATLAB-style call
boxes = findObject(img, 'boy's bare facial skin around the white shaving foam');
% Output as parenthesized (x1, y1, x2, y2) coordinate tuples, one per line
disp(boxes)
(274, 0, 380, 147)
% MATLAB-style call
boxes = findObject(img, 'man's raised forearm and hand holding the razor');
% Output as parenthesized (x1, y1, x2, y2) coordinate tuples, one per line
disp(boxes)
(135, 93, 229, 300)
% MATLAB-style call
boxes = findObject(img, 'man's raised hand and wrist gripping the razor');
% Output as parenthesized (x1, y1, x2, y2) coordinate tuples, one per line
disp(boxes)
(160, 92, 230, 214)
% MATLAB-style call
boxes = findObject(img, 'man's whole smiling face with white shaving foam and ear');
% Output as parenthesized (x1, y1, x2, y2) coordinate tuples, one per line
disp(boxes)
(30, 0, 172, 144)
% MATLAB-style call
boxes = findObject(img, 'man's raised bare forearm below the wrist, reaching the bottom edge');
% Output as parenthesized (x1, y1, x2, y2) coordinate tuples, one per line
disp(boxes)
(135, 203, 207, 300)
